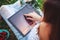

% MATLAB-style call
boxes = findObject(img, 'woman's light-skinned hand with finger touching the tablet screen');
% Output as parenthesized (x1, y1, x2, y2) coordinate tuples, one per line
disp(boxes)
(24, 12, 42, 21)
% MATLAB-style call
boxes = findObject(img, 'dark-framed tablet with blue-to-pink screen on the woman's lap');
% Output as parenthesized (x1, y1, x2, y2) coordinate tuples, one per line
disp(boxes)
(8, 5, 36, 35)
